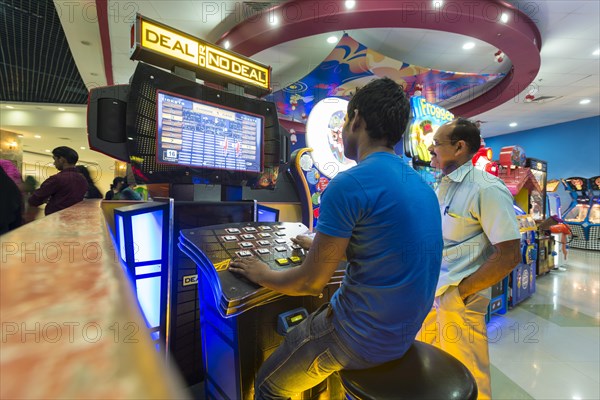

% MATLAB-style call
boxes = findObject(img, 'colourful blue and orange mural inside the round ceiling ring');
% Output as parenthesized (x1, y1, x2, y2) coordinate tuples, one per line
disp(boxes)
(267, 34, 505, 123)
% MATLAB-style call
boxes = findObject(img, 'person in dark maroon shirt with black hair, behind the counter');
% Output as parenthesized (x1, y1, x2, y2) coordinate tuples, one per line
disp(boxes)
(28, 146, 88, 215)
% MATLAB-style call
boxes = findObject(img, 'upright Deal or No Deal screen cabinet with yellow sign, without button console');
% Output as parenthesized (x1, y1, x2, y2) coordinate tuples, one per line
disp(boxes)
(88, 15, 314, 390)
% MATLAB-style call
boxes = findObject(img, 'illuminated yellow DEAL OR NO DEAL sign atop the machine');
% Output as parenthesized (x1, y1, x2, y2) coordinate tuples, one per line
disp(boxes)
(131, 15, 271, 94)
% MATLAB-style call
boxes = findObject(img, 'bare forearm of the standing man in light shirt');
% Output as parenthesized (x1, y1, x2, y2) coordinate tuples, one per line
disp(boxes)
(458, 239, 521, 300)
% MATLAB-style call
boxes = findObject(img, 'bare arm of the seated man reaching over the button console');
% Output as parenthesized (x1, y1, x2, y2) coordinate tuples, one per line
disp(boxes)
(229, 232, 350, 296)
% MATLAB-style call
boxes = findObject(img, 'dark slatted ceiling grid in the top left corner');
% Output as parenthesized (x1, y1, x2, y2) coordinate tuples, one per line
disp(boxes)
(0, 0, 88, 104)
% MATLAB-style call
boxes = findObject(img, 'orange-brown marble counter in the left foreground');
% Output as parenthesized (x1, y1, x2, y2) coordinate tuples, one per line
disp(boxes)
(0, 200, 188, 399)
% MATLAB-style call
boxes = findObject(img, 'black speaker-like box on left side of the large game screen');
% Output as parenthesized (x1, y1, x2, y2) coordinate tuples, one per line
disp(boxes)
(87, 85, 130, 162)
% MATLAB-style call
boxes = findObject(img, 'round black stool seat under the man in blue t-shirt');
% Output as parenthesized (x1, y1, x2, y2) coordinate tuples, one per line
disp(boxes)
(339, 341, 477, 400)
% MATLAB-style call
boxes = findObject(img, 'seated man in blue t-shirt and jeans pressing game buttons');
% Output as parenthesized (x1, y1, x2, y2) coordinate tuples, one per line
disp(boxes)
(230, 78, 443, 399)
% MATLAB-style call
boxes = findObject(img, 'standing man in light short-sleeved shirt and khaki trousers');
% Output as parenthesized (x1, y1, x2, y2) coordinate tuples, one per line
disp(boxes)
(417, 118, 521, 399)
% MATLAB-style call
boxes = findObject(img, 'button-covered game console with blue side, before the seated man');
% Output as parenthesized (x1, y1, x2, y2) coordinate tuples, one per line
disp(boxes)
(179, 222, 345, 400)
